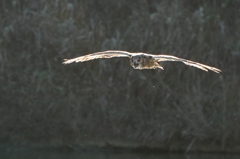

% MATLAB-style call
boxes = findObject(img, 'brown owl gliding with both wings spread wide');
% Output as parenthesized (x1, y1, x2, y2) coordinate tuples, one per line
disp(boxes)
(63, 50, 221, 73)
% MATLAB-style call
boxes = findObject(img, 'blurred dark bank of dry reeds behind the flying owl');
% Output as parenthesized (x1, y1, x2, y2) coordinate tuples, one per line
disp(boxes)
(0, 0, 240, 152)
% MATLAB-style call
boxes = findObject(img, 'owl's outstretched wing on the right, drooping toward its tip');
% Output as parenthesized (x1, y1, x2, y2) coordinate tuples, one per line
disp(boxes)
(153, 55, 221, 73)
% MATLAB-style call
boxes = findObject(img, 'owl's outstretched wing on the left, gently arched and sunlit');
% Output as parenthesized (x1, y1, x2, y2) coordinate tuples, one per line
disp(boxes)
(63, 50, 132, 64)
